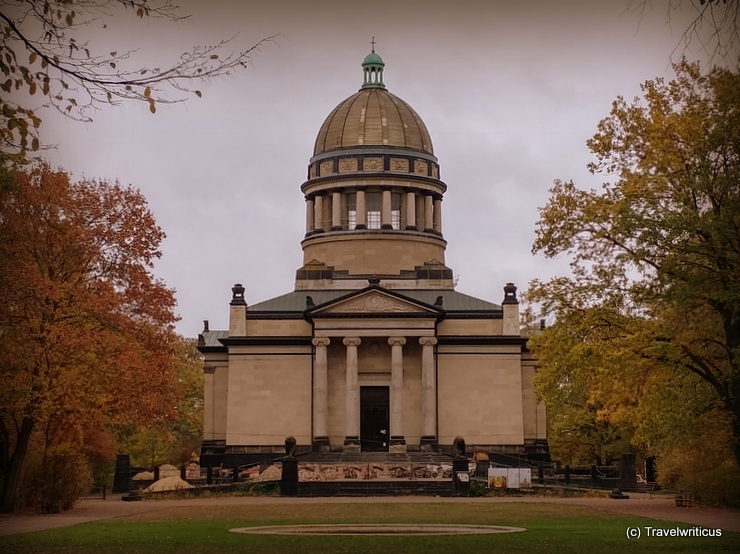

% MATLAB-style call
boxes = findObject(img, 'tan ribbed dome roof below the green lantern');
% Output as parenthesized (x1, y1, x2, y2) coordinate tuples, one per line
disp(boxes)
(314, 88, 434, 156)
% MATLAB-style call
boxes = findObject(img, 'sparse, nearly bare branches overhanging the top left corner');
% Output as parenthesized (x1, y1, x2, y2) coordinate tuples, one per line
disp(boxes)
(0, 0, 274, 152)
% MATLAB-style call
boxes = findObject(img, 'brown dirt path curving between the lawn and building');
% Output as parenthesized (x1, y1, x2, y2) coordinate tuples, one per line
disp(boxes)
(0, 494, 740, 536)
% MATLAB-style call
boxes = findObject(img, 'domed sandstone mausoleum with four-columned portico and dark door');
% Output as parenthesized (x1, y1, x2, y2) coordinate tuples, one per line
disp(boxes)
(198, 50, 546, 467)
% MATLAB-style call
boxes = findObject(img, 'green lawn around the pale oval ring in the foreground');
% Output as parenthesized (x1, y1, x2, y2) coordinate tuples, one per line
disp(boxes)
(0, 503, 740, 554)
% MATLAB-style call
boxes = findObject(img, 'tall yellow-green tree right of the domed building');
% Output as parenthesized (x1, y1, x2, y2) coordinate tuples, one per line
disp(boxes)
(529, 61, 740, 470)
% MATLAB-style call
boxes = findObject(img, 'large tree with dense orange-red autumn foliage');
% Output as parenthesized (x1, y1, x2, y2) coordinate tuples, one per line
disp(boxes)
(0, 158, 178, 512)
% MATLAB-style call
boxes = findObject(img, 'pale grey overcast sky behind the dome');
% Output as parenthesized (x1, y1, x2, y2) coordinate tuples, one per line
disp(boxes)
(34, 0, 704, 336)
